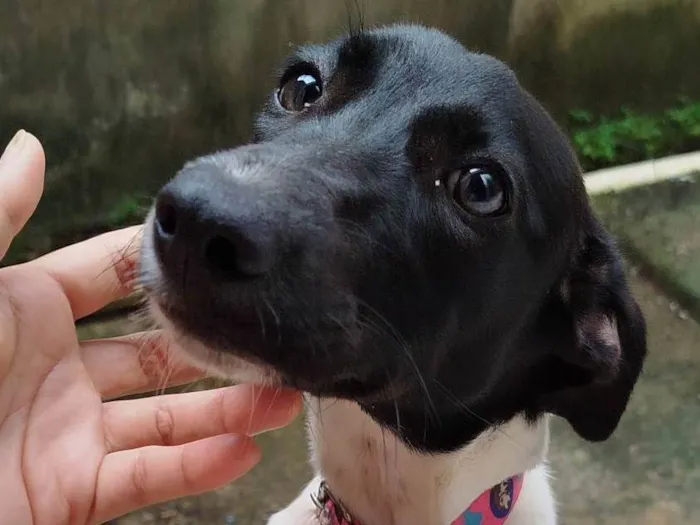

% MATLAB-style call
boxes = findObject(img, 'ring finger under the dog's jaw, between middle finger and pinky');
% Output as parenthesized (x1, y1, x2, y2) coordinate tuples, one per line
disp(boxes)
(103, 385, 302, 452)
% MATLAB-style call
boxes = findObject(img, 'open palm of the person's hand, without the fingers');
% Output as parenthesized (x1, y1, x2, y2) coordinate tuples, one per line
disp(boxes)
(0, 270, 107, 525)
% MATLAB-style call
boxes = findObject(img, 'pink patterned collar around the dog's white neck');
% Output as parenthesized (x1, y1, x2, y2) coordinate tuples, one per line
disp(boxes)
(312, 474, 523, 525)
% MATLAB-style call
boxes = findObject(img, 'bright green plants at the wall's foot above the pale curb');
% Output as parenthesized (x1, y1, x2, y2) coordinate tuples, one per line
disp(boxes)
(569, 98, 700, 170)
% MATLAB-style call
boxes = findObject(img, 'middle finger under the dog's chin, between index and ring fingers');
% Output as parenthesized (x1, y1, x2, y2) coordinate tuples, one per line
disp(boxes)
(80, 330, 205, 399)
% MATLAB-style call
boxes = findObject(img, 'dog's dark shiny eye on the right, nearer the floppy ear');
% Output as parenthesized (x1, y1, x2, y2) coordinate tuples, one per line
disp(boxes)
(446, 165, 508, 216)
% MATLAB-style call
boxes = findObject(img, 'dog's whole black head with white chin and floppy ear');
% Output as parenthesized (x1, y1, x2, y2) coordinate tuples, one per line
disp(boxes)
(142, 26, 646, 451)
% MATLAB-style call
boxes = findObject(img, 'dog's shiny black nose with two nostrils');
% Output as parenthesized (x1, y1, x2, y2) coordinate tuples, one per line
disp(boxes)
(153, 165, 275, 286)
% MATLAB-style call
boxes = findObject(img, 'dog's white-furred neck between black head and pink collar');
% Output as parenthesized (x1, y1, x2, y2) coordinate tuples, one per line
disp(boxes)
(308, 398, 549, 525)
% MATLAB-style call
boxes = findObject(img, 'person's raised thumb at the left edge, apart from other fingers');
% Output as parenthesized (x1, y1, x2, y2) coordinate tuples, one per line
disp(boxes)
(0, 130, 46, 259)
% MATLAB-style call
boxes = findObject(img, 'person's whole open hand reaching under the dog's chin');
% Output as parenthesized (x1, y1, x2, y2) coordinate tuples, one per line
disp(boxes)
(0, 128, 301, 525)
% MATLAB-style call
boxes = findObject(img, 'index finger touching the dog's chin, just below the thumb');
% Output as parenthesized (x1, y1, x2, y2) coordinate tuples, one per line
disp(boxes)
(27, 226, 141, 319)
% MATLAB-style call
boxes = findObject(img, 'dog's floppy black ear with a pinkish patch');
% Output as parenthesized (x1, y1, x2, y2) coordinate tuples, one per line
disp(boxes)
(542, 218, 647, 441)
